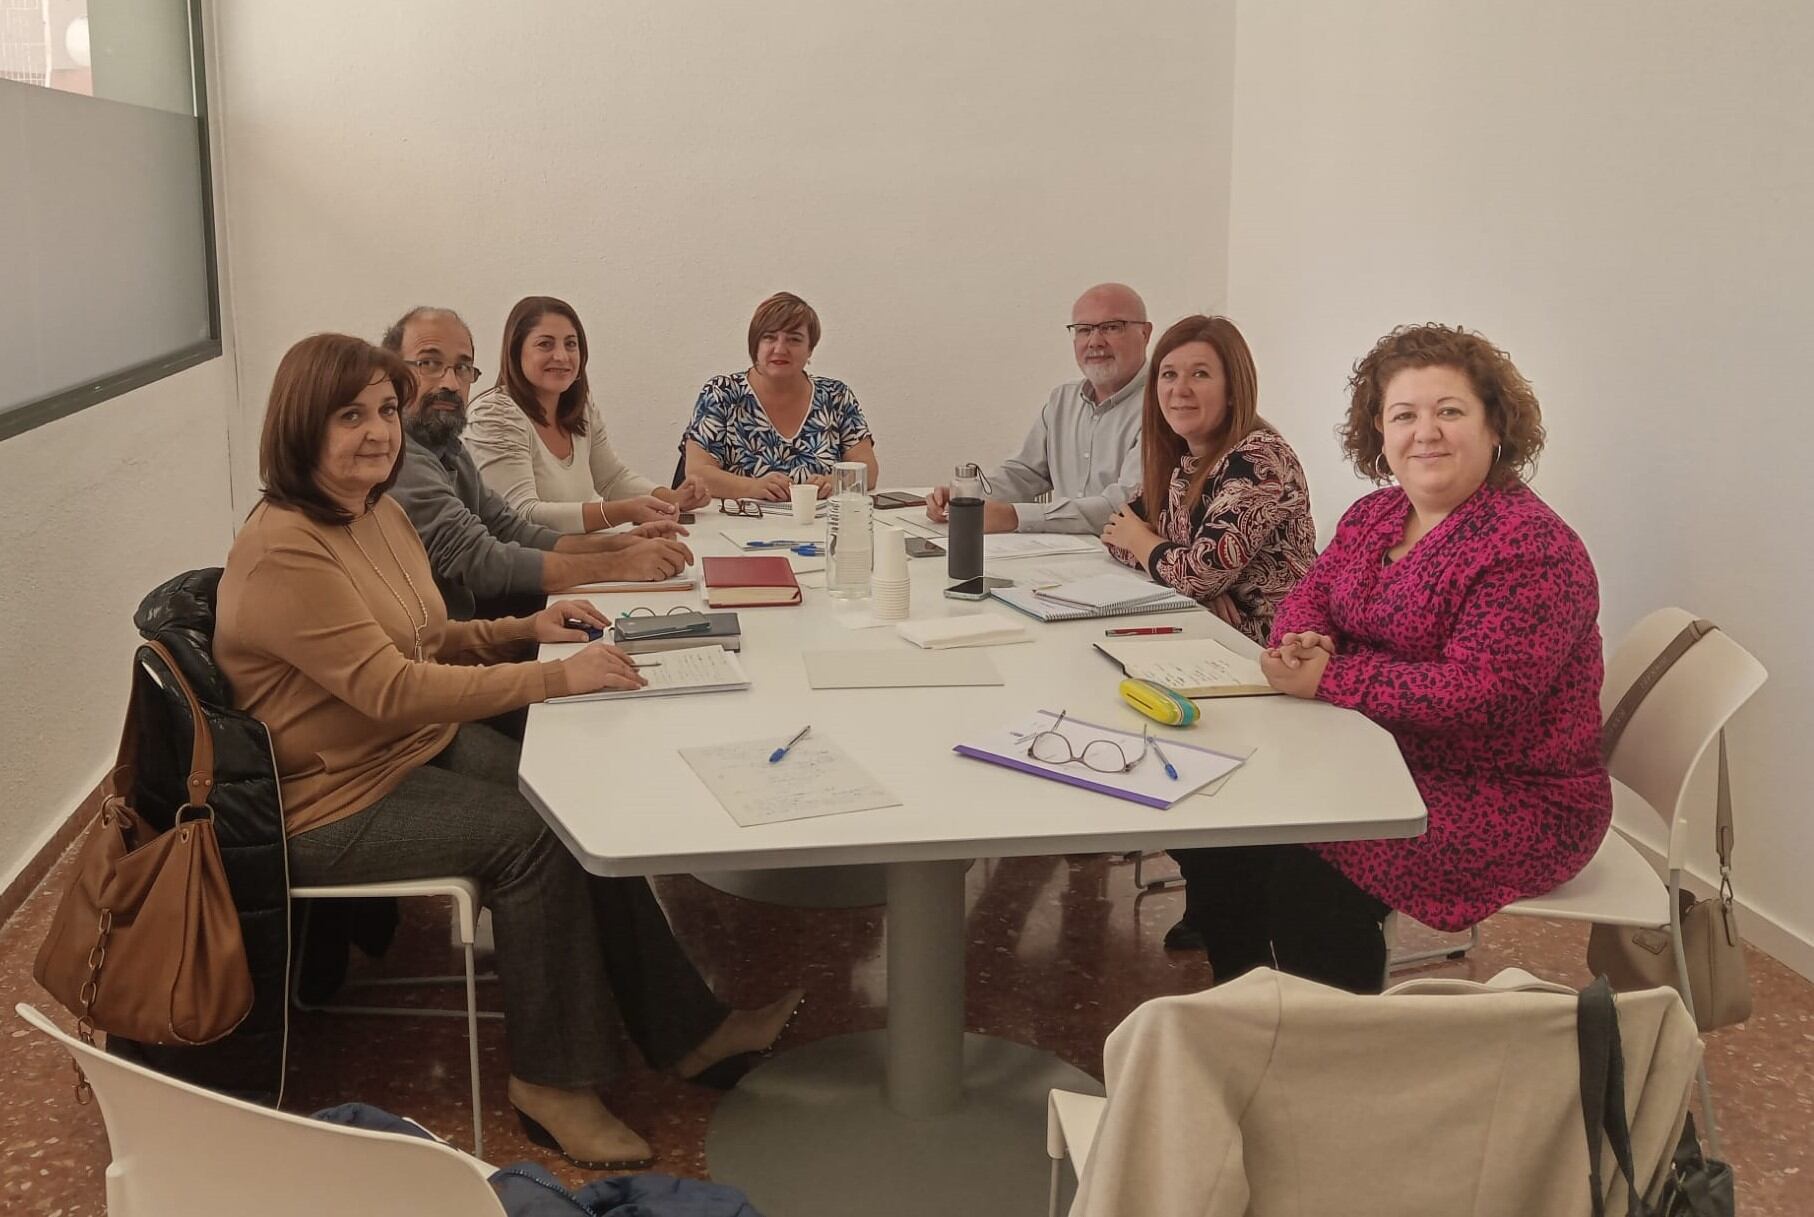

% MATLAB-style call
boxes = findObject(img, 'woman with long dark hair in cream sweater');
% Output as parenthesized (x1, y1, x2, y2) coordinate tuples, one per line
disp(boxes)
(466, 296, 707, 533)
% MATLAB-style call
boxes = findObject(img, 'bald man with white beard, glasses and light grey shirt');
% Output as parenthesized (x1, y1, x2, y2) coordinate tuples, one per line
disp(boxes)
(925, 283, 1152, 535)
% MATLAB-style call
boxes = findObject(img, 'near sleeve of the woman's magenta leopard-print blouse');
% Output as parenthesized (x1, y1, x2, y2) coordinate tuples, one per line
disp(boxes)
(1320, 528, 1600, 731)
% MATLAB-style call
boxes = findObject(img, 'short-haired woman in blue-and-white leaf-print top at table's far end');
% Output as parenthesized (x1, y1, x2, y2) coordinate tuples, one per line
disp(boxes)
(682, 292, 880, 501)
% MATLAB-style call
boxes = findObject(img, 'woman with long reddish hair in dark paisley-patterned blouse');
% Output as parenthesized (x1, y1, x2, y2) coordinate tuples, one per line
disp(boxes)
(1103, 316, 1317, 642)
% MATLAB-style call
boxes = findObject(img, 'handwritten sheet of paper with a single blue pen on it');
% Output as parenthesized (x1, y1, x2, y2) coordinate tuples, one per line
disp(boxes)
(680, 733, 902, 829)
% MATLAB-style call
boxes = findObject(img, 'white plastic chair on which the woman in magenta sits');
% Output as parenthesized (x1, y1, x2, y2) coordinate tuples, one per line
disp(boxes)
(1388, 608, 1769, 1154)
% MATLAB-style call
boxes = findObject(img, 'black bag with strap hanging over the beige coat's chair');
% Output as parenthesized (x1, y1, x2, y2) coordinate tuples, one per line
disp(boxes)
(1575, 976, 1736, 1217)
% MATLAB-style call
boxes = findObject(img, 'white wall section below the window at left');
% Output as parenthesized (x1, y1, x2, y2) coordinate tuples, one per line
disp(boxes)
(0, 359, 234, 889)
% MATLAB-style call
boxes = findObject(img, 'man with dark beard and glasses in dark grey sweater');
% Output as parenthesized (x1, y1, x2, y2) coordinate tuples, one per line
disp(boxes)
(385, 307, 693, 620)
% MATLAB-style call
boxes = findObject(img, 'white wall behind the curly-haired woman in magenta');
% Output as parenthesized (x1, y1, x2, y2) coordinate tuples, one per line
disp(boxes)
(1228, 0, 1814, 974)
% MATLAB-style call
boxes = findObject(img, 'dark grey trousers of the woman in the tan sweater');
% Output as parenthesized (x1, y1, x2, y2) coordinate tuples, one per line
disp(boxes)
(290, 724, 729, 1088)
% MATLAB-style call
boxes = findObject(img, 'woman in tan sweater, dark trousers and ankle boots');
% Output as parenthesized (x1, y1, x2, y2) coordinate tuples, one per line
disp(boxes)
(214, 334, 800, 1170)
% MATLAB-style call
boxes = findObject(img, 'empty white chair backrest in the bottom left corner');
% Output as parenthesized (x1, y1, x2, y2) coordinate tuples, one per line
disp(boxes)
(15, 1003, 504, 1217)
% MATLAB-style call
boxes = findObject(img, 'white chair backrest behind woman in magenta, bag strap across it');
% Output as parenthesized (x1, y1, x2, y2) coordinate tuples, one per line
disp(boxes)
(1600, 608, 1769, 867)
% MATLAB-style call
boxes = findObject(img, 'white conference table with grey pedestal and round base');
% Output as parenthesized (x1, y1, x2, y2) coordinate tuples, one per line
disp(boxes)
(519, 508, 1426, 1217)
